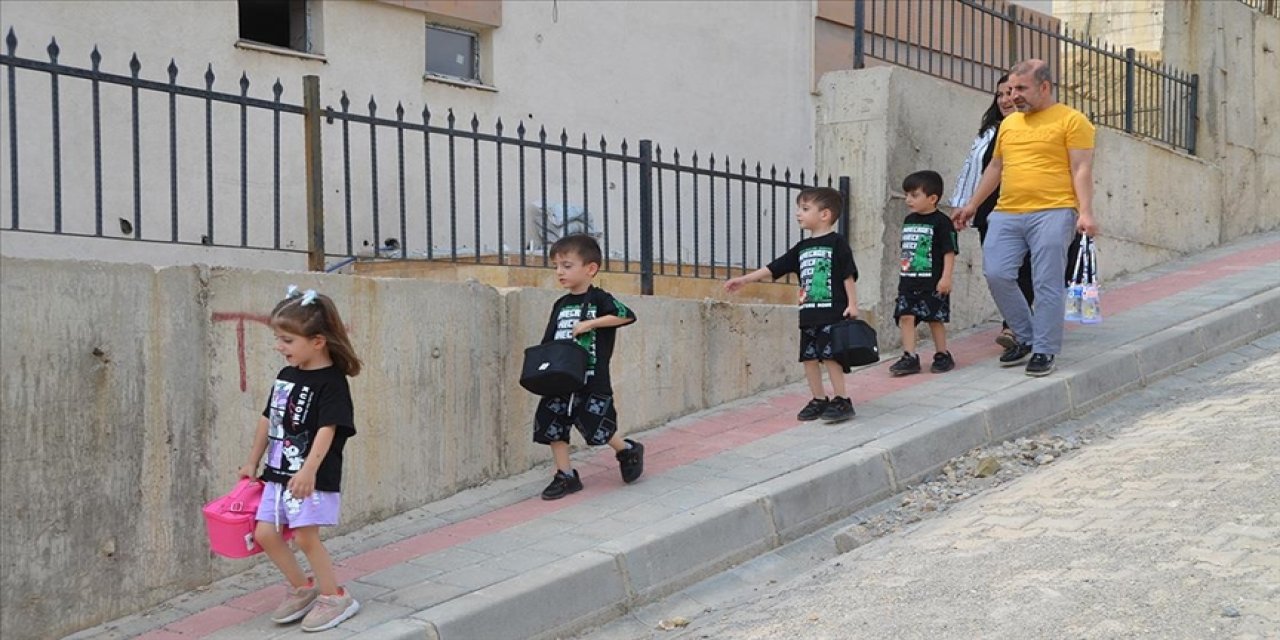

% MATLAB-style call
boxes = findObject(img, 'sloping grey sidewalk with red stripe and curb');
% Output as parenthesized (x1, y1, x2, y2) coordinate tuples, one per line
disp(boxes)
(72, 233, 1280, 640)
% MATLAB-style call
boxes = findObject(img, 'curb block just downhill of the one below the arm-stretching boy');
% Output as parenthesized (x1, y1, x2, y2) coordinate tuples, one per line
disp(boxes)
(598, 493, 778, 602)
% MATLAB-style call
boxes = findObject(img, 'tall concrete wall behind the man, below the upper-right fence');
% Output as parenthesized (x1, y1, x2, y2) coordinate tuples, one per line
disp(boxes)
(817, 67, 1249, 347)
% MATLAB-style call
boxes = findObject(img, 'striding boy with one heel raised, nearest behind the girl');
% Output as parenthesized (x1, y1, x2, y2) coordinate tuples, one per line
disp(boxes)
(534, 234, 644, 500)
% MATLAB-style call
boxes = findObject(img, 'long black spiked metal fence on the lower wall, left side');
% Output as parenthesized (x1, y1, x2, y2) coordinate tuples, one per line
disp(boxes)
(0, 29, 849, 293)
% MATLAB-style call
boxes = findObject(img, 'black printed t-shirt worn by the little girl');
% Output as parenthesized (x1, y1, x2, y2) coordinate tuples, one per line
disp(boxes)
(262, 366, 356, 492)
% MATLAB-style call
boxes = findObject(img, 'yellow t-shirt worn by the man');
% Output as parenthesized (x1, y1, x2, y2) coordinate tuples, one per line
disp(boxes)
(992, 104, 1093, 214)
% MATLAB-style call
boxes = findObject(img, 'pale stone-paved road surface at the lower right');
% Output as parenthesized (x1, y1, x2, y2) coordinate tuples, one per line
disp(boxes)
(614, 334, 1280, 640)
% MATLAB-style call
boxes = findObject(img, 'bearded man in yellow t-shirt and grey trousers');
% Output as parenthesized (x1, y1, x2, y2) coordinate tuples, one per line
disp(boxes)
(951, 60, 1098, 376)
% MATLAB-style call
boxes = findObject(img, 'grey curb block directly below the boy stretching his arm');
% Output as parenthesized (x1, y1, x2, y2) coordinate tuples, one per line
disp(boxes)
(744, 449, 891, 540)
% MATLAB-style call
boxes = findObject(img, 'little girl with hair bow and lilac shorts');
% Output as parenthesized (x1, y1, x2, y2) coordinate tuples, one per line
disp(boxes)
(239, 287, 361, 631)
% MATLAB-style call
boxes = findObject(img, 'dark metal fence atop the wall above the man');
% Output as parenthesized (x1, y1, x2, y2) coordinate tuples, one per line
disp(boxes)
(854, 0, 1198, 154)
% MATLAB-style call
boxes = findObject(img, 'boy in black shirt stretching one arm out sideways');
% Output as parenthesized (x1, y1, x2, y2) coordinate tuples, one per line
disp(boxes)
(724, 187, 858, 422)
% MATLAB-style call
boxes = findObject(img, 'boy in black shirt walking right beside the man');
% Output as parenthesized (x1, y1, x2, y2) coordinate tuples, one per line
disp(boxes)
(888, 172, 959, 375)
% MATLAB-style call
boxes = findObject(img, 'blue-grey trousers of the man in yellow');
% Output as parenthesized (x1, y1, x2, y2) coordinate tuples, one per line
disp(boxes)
(982, 209, 1075, 355)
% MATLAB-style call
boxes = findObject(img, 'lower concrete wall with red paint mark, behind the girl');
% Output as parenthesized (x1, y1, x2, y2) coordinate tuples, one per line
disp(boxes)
(0, 259, 801, 639)
